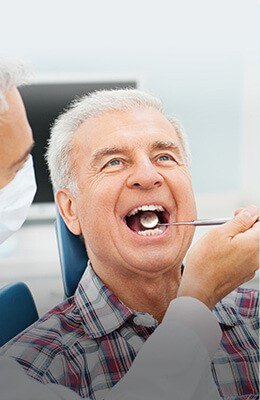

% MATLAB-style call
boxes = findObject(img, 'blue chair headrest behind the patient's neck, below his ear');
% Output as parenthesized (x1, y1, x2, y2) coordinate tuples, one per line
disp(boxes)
(55, 210, 88, 298)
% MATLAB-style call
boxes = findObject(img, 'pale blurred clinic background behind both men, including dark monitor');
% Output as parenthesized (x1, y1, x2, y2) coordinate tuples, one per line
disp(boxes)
(0, 0, 260, 314)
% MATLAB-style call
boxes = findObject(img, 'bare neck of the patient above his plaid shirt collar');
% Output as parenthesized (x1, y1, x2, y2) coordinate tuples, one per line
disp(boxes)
(93, 266, 181, 323)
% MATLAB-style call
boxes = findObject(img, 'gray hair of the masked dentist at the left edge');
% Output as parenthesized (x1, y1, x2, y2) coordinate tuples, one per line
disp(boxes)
(0, 58, 31, 113)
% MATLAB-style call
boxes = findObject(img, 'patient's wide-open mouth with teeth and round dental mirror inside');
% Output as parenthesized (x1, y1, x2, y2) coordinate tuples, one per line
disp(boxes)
(124, 205, 170, 236)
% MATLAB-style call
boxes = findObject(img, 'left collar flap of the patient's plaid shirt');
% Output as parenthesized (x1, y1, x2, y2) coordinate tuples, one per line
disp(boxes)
(75, 262, 134, 338)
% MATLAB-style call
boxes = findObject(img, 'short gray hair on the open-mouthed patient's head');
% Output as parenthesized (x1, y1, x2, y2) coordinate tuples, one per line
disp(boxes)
(45, 89, 190, 195)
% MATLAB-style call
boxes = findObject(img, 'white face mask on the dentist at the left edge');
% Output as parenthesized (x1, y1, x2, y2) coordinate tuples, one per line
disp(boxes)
(0, 155, 36, 244)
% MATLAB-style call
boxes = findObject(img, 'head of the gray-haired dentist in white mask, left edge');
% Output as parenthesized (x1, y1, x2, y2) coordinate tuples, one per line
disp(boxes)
(0, 64, 36, 244)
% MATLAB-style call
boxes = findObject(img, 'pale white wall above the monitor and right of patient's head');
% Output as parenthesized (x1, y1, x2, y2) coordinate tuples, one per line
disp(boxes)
(0, 0, 260, 207)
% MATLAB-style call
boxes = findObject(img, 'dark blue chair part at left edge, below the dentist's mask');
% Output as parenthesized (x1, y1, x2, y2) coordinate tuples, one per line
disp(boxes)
(0, 282, 39, 347)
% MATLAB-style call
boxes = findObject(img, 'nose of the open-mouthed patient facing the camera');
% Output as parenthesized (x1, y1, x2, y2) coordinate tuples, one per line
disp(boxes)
(127, 159, 163, 190)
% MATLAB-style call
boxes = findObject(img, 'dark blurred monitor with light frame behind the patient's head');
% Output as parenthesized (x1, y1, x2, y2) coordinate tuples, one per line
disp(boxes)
(19, 76, 139, 220)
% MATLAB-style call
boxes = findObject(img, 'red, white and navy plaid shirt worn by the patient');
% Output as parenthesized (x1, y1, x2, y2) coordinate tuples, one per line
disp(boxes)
(2, 266, 259, 400)
